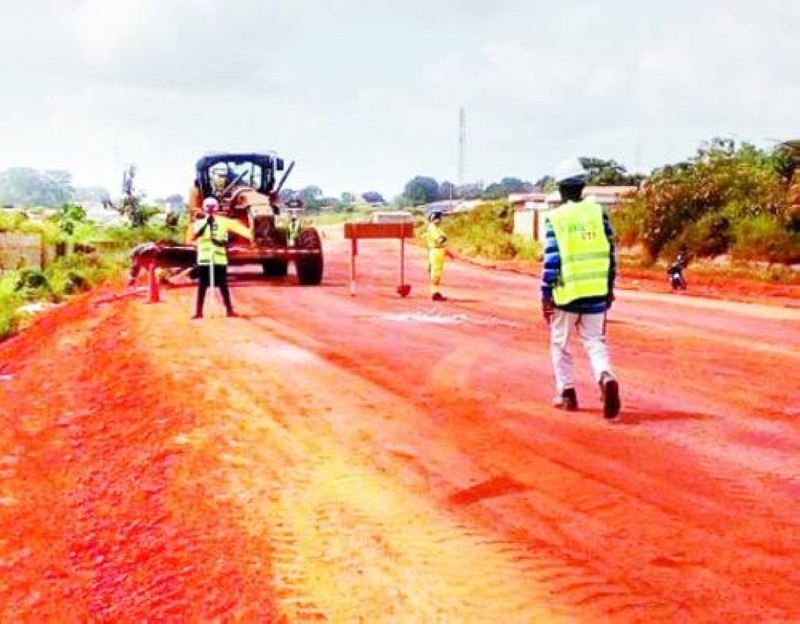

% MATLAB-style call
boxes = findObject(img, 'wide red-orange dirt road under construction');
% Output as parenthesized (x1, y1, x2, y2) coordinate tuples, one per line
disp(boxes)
(0, 227, 800, 623)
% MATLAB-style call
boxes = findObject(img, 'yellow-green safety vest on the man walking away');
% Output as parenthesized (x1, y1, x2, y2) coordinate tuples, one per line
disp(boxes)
(546, 200, 611, 305)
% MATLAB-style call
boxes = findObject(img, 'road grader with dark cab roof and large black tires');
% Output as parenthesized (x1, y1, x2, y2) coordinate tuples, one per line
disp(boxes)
(131, 152, 324, 286)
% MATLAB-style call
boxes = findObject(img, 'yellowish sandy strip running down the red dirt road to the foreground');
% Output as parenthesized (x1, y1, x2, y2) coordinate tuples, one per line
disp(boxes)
(138, 304, 569, 623)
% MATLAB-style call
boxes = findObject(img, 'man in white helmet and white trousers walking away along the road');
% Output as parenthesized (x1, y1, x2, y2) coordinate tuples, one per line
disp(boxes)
(541, 159, 621, 419)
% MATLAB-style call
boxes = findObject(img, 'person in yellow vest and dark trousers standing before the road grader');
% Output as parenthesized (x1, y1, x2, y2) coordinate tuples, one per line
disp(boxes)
(192, 197, 251, 319)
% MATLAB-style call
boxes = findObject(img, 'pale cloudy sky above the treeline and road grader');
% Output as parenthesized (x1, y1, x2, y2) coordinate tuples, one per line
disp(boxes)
(0, 0, 800, 199)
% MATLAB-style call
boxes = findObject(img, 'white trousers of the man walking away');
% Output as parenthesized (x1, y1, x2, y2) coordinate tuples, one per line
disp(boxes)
(550, 309, 613, 394)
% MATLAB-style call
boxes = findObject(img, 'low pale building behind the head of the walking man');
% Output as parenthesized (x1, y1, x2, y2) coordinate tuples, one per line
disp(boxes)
(508, 186, 638, 242)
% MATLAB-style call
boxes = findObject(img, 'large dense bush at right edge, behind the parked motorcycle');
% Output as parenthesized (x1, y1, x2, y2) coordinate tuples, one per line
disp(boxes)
(615, 139, 800, 263)
